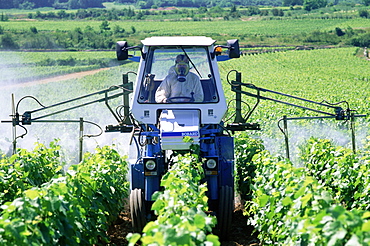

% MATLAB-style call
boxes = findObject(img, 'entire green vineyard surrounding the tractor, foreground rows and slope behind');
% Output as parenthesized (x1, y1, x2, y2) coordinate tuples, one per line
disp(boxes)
(0, 46, 370, 245)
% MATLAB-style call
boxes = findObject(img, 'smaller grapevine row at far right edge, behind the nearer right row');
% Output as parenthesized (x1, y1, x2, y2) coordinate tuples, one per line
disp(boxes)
(301, 138, 370, 210)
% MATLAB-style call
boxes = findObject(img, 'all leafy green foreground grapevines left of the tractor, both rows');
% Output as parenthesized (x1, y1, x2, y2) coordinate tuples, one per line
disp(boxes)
(0, 145, 128, 245)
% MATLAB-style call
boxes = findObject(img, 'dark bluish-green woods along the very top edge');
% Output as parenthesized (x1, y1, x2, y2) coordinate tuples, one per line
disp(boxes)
(0, 0, 370, 9)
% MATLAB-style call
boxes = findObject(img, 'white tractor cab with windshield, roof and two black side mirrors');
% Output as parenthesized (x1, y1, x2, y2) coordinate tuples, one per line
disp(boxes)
(117, 37, 239, 127)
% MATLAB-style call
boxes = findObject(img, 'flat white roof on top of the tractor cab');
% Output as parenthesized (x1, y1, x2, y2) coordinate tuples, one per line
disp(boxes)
(141, 36, 216, 46)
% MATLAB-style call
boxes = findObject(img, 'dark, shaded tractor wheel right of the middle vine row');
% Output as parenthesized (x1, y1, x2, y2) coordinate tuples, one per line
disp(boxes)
(217, 186, 234, 241)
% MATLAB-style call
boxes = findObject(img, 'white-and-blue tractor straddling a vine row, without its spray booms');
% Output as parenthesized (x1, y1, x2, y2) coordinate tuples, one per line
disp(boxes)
(117, 37, 239, 238)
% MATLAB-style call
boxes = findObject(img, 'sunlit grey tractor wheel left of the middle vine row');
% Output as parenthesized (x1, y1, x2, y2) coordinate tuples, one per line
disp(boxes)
(130, 189, 146, 232)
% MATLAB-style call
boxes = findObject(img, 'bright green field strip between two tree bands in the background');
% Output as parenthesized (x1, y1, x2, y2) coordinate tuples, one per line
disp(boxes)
(0, 18, 370, 37)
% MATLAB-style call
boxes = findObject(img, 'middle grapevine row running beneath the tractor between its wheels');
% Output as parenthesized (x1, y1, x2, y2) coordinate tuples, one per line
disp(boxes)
(128, 154, 220, 245)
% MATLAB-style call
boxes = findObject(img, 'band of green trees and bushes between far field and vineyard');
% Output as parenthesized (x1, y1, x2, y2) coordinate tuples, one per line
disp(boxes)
(0, 21, 370, 50)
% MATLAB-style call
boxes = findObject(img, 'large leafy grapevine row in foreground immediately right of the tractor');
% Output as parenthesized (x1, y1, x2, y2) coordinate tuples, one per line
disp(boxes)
(237, 134, 370, 245)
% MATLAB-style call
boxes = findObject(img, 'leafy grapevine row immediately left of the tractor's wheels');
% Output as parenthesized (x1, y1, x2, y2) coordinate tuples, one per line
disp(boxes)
(0, 147, 128, 246)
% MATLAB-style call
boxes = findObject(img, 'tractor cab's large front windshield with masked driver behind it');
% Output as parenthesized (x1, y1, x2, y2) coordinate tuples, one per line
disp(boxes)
(138, 47, 218, 103)
